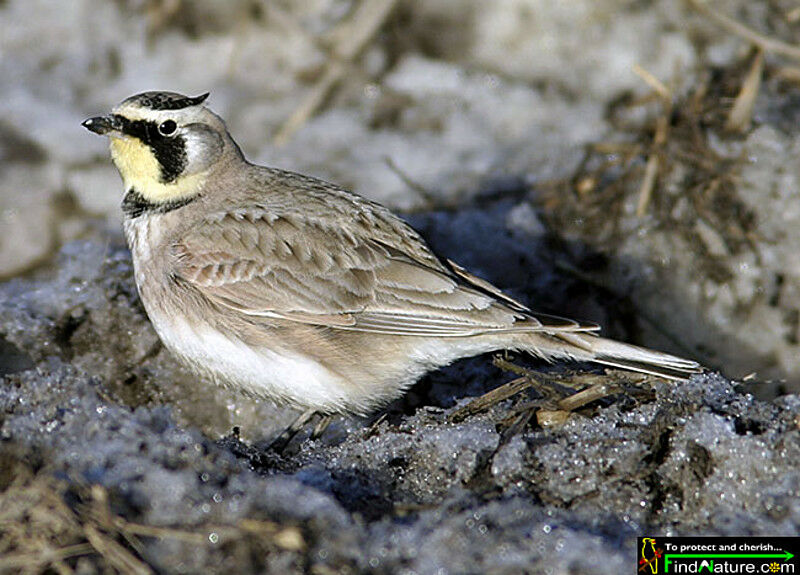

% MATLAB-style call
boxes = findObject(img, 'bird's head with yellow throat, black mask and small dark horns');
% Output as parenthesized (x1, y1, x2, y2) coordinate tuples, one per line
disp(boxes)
(83, 92, 241, 210)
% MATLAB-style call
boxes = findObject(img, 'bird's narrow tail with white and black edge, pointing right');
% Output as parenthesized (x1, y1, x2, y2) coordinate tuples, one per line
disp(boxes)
(528, 331, 702, 381)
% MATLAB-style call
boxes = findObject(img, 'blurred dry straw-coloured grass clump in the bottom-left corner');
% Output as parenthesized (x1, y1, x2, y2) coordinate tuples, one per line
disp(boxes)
(0, 451, 306, 575)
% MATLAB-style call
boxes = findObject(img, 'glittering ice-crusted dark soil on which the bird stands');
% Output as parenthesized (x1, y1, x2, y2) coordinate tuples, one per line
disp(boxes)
(0, 223, 800, 573)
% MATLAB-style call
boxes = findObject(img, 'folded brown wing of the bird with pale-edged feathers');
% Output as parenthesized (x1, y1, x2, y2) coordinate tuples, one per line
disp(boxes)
(172, 204, 594, 336)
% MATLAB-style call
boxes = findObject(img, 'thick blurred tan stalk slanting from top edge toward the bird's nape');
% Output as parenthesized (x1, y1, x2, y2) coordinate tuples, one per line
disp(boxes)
(274, 0, 397, 146)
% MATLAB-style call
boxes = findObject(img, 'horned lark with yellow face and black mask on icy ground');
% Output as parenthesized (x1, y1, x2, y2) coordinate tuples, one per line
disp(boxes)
(83, 92, 699, 414)
